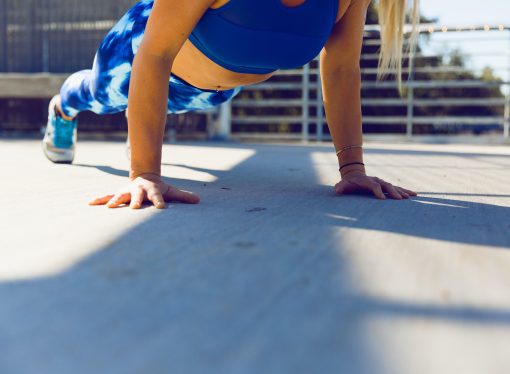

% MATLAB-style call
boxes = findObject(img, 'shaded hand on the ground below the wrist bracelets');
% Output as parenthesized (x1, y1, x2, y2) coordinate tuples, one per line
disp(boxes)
(335, 173, 418, 200)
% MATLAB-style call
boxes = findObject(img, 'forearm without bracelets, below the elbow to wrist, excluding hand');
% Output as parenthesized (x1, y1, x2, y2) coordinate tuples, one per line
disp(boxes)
(128, 49, 172, 179)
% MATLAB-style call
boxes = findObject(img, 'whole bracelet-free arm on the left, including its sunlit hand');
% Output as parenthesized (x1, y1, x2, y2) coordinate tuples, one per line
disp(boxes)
(89, 0, 214, 209)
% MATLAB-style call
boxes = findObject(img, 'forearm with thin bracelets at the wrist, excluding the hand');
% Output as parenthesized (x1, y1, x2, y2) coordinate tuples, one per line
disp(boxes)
(323, 68, 364, 177)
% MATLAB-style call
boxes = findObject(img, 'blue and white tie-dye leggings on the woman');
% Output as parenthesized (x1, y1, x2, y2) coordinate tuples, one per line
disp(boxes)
(60, 0, 242, 117)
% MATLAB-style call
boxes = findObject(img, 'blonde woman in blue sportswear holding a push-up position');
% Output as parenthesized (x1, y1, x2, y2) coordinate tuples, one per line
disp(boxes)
(43, 0, 418, 209)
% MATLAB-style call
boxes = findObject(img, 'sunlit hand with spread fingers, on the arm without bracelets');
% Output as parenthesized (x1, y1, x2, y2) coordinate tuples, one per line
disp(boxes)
(89, 174, 200, 209)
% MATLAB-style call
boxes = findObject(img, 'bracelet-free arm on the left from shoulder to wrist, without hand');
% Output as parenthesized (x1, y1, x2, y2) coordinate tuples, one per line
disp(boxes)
(128, 0, 214, 179)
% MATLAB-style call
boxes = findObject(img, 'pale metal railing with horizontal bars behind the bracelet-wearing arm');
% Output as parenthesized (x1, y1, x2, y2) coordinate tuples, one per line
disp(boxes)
(219, 25, 510, 141)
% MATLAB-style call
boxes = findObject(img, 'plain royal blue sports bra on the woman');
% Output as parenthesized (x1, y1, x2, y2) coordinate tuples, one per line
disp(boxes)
(189, 0, 338, 74)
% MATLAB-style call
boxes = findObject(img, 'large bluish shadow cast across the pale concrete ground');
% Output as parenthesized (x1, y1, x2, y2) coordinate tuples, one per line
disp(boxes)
(0, 142, 510, 374)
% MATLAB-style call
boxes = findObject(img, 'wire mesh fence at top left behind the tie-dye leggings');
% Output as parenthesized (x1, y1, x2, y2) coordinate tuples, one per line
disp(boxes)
(0, 0, 136, 73)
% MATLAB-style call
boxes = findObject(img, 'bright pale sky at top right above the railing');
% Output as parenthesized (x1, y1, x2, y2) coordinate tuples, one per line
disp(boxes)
(420, 0, 510, 81)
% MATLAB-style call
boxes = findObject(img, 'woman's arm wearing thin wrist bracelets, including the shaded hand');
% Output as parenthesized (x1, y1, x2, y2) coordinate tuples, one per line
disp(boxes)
(320, 0, 416, 200)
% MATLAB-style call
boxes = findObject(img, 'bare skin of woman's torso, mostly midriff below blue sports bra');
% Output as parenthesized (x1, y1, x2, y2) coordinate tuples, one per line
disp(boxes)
(172, 0, 352, 90)
